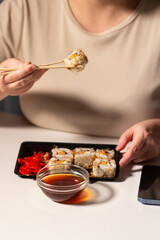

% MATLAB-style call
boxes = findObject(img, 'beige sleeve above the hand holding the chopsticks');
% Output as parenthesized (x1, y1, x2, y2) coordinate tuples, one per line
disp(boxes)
(0, 0, 24, 62)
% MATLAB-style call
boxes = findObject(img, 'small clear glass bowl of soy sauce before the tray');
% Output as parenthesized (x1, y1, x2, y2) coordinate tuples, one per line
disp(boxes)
(36, 163, 89, 203)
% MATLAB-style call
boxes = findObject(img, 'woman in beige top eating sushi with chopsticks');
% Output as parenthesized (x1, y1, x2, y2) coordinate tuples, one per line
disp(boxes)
(0, 0, 160, 166)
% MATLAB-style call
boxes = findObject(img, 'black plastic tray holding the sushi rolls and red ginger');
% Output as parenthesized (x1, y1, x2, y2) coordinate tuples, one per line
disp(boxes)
(14, 142, 120, 181)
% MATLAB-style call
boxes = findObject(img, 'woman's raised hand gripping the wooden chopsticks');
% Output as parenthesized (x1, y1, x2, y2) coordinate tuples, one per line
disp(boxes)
(0, 58, 46, 98)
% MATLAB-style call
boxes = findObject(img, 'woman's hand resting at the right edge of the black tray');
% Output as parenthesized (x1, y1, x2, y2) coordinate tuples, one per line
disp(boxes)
(116, 119, 160, 167)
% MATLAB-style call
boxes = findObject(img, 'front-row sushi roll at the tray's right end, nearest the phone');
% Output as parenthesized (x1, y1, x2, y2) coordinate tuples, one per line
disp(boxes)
(92, 158, 116, 178)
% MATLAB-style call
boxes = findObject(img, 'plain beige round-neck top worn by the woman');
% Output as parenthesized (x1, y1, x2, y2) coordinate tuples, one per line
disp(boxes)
(0, 0, 160, 137)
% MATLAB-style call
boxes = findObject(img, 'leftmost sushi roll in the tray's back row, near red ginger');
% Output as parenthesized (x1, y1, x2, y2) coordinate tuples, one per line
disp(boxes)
(51, 147, 73, 162)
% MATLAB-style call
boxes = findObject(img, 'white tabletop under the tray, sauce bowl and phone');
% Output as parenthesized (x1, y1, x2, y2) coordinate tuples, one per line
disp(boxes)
(0, 113, 160, 240)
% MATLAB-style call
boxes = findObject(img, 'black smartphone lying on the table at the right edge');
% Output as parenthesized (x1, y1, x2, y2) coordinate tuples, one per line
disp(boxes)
(138, 165, 160, 205)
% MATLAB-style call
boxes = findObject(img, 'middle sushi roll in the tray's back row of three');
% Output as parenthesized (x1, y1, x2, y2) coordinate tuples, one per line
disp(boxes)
(74, 148, 95, 169)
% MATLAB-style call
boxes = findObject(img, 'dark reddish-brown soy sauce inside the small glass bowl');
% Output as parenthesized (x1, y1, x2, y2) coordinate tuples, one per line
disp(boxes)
(42, 174, 84, 202)
